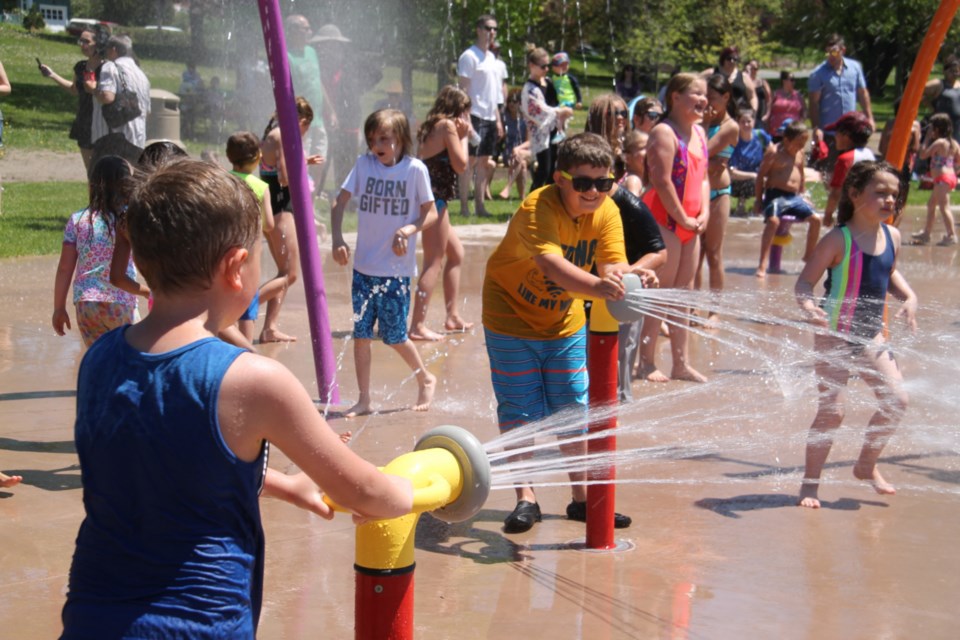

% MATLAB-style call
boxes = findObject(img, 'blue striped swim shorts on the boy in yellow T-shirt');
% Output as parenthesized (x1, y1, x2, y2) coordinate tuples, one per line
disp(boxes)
(483, 327, 589, 432)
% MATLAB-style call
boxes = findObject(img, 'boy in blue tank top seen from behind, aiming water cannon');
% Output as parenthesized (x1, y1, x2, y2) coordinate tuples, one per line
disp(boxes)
(62, 160, 412, 638)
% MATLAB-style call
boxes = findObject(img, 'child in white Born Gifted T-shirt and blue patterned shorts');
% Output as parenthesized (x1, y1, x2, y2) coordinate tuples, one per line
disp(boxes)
(330, 109, 437, 417)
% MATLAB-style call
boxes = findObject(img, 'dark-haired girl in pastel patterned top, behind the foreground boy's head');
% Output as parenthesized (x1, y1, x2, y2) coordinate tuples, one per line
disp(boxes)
(52, 156, 139, 347)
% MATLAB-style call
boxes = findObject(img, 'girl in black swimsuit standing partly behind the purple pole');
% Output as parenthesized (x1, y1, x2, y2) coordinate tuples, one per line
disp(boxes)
(260, 97, 325, 343)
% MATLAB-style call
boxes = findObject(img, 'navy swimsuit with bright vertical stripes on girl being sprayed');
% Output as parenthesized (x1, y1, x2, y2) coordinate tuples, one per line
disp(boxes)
(822, 224, 896, 338)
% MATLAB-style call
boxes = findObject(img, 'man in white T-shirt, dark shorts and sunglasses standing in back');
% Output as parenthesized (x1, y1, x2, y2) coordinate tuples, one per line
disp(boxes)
(457, 14, 503, 216)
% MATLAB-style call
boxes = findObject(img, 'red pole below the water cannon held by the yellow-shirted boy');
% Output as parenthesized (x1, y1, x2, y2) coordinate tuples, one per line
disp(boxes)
(586, 324, 617, 549)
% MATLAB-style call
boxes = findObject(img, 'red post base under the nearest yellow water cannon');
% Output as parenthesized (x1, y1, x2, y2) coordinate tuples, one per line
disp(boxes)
(354, 565, 415, 640)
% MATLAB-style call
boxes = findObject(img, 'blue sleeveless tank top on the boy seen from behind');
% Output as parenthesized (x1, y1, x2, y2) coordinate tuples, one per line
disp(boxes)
(62, 327, 268, 638)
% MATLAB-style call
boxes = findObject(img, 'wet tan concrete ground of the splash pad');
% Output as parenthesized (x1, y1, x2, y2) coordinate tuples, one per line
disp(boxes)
(0, 212, 960, 640)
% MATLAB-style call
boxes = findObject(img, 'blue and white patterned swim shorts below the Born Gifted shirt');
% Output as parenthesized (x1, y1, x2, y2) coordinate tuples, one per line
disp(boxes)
(351, 270, 410, 344)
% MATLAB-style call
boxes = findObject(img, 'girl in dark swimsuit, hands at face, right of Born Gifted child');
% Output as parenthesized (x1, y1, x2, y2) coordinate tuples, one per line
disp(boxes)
(410, 86, 473, 341)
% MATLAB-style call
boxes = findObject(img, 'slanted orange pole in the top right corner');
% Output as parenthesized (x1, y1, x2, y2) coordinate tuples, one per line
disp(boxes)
(887, 0, 960, 169)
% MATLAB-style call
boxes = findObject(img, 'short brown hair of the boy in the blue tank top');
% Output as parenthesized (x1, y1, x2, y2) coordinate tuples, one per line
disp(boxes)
(126, 159, 260, 292)
